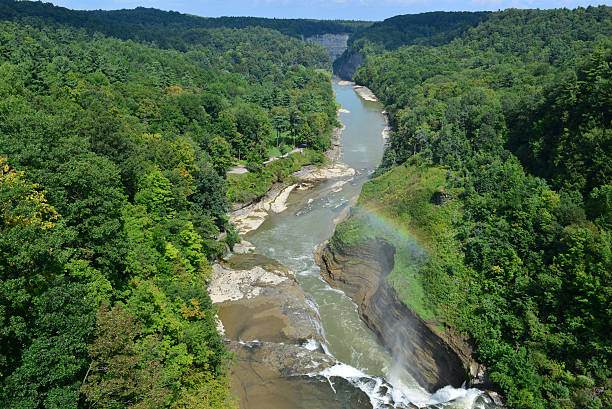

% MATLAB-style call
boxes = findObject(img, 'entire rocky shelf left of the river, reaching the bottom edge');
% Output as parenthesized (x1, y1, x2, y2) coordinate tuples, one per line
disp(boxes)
(208, 241, 408, 409)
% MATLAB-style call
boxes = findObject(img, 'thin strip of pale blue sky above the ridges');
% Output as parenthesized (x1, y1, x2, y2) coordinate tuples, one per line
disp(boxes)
(47, 0, 610, 20)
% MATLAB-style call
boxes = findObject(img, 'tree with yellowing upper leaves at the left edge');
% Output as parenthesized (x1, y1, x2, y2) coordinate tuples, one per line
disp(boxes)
(0, 158, 72, 376)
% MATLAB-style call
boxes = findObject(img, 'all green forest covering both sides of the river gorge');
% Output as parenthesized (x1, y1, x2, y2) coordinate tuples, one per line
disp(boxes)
(0, 0, 612, 409)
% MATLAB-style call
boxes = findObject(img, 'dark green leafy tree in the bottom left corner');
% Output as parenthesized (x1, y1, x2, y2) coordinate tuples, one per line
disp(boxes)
(0, 279, 94, 409)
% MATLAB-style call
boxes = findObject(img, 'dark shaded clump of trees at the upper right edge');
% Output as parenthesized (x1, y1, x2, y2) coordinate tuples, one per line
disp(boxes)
(509, 42, 612, 197)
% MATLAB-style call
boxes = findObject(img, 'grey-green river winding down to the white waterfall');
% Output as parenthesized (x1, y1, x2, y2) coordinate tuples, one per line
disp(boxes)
(246, 81, 488, 409)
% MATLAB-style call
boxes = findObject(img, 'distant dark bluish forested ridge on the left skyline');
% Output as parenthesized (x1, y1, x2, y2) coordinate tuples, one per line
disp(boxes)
(0, 0, 371, 47)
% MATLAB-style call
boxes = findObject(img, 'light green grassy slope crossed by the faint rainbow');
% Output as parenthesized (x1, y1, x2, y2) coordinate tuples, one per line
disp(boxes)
(331, 161, 462, 321)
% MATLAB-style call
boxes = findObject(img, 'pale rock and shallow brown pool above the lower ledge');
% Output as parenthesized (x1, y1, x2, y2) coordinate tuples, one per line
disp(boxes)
(208, 253, 323, 345)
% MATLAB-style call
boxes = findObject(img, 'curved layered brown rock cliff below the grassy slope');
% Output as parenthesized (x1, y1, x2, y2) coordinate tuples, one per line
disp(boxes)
(316, 234, 469, 392)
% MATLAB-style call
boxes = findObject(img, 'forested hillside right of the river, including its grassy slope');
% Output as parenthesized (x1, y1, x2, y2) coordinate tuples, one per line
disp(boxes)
(331, 6, 612, 409)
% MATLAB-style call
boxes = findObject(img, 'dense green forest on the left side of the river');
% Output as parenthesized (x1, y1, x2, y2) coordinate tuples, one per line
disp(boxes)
(0, 0, 336, 409)
